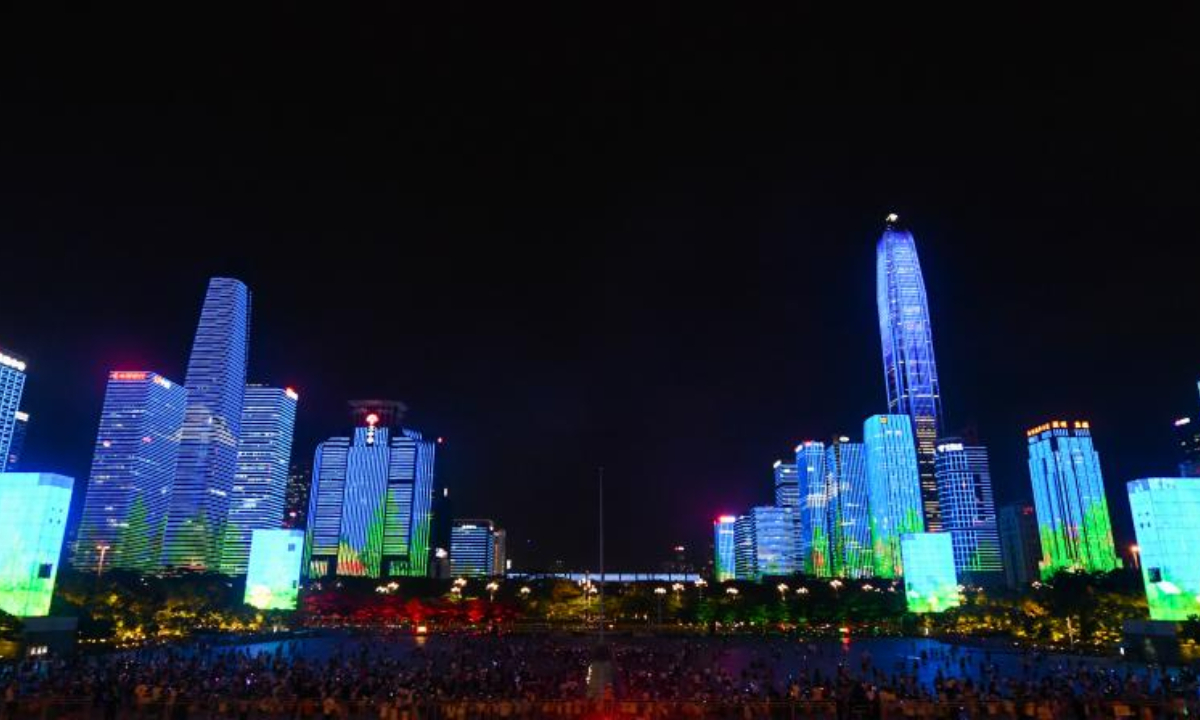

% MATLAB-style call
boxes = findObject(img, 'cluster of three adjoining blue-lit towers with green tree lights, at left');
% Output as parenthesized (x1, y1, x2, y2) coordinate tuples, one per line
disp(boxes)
(72, 277, 299, 575)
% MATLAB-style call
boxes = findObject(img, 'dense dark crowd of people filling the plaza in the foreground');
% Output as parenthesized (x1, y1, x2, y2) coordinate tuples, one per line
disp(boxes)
(0, 636, 1200, 720)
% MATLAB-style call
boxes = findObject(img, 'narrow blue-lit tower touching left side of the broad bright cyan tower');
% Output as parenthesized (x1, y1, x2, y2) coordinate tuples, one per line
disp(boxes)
(824, 437, 875, 577)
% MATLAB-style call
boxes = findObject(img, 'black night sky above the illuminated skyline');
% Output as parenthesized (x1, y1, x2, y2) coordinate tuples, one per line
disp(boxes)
(0, 2, 1200, 569)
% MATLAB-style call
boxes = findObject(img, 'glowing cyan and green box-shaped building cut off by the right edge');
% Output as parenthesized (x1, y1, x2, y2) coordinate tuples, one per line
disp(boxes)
(1127, 478, 1200, 620)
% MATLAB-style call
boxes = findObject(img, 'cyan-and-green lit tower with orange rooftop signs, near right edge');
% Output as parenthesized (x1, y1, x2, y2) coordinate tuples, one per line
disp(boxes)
(1026, 420, 1121, 577)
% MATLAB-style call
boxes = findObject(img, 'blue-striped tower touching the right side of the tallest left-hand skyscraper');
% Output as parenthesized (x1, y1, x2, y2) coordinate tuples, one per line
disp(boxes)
(221, 385, 300, 575)
